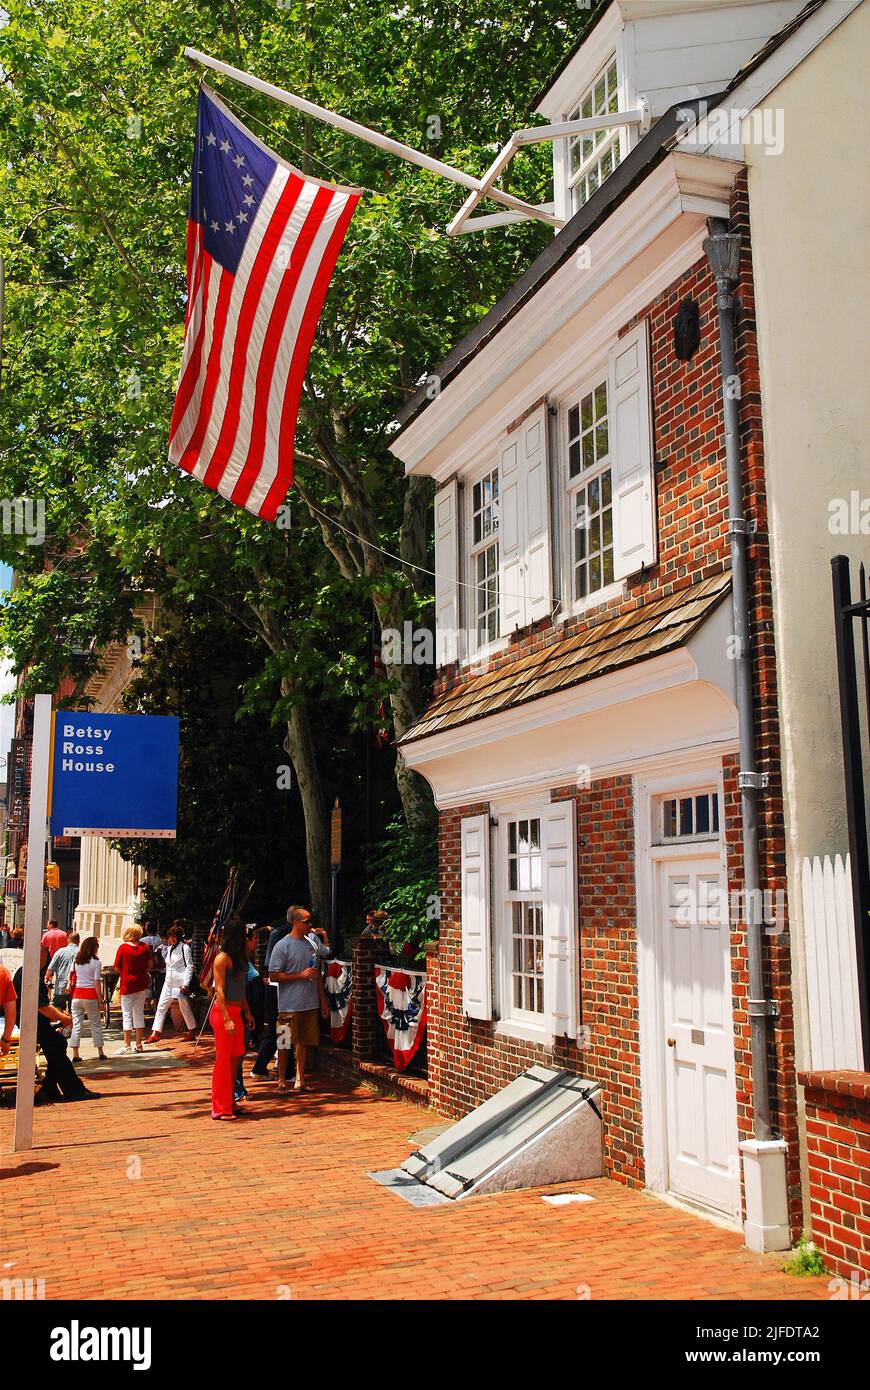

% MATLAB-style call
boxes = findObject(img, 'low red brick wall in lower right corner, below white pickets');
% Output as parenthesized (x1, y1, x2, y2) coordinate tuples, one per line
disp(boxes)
(798, 1072, 870, 1279)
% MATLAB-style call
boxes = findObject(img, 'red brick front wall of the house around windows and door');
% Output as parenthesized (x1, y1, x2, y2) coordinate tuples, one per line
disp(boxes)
(422, 177, 801, 1232)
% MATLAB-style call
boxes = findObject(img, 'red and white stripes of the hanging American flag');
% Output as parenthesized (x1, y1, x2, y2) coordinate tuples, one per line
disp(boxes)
(170, 165, 360, 521)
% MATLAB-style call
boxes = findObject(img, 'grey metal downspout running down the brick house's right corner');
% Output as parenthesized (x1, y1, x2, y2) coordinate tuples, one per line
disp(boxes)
(703, 218, 774, 1140)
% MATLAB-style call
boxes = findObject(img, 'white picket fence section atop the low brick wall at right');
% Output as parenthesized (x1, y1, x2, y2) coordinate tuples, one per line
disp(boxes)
(801, 855, 863, 1070)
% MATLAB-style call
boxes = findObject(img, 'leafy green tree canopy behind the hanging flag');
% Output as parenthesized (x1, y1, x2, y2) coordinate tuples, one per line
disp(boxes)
(0, 0, 591, 934)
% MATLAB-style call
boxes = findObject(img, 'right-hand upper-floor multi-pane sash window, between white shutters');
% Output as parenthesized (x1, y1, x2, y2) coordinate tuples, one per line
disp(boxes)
(567, 374, 614, 602)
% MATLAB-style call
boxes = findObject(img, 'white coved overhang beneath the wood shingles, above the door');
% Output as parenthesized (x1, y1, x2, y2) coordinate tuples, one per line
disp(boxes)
(400, 575, 738, 810)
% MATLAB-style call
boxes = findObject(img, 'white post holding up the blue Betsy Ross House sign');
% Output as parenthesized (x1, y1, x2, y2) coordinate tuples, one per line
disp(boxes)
(13, 695, 51, 1154)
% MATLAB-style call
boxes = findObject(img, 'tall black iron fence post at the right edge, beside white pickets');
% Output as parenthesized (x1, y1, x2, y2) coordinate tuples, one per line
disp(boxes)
(831, 555, 870, 1070)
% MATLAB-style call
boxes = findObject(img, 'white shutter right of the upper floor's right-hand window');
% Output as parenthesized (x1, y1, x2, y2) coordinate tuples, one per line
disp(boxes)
(609, 320, 656, 580)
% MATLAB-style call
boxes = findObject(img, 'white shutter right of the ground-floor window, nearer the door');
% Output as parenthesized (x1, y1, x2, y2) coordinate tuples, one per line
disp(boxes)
(542, 801, 580, 1038)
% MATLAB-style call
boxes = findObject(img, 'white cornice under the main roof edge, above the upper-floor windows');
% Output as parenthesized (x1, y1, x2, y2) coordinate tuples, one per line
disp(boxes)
(391, 152, 742, 481)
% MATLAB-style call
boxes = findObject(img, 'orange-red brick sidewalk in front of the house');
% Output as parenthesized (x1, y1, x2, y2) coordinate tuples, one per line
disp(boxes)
(0, 1045, 828, 1300)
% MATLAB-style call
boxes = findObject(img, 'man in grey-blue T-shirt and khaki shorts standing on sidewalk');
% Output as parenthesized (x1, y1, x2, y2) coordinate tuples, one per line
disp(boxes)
(268, 908, 329, 1095)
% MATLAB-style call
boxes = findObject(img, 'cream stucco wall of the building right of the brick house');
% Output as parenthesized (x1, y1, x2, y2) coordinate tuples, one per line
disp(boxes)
(746, 0, 870, 1066)
